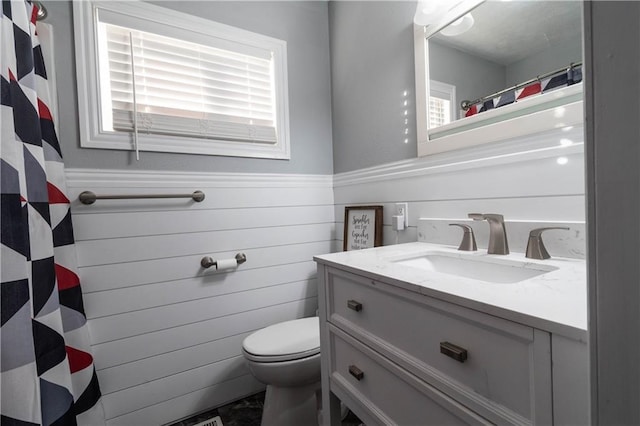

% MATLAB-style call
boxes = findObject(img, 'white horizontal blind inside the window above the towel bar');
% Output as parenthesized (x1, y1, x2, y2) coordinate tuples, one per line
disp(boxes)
(98, 22, 277, 144)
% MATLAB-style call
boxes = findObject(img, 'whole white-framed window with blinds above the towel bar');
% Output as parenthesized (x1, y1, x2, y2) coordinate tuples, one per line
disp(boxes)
(74, 2, 289, 159)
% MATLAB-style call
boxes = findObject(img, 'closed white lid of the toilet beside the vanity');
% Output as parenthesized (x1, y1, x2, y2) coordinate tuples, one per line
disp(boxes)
(242, 317, 320, 359)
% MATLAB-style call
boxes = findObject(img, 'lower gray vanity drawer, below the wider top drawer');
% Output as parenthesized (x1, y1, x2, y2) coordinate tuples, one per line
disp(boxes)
(330, 327, 491, 425)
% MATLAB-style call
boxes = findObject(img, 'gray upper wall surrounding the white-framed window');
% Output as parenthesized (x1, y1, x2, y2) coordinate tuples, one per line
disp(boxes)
(45, 1, 333, 174)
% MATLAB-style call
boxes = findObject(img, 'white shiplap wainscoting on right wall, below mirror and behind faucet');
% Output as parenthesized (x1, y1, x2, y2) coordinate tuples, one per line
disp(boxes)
(334, 126, 585, 255)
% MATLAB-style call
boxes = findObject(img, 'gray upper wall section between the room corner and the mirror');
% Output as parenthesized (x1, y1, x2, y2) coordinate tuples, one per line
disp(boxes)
(329, 1, 417, 173)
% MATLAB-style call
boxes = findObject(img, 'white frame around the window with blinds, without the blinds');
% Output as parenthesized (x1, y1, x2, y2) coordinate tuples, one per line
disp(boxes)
(73, 1, 290, 159)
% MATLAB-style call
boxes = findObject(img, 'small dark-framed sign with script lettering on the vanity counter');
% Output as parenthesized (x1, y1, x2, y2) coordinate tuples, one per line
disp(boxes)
(343, 206, 382, 251)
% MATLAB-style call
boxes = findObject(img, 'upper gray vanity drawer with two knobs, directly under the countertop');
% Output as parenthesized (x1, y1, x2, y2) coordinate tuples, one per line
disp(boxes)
(326, 269, 552, 424)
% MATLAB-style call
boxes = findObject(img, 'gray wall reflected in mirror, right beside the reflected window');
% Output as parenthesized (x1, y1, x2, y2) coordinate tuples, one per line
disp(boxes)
(429, 41, 506, 114)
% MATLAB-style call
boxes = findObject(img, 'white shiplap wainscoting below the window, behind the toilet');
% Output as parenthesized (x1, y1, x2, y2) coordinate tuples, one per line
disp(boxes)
(67, 169, 336, 425)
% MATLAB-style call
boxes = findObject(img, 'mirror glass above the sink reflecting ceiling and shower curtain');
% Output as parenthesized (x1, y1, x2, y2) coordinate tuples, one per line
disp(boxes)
(428, 1, 582, 134)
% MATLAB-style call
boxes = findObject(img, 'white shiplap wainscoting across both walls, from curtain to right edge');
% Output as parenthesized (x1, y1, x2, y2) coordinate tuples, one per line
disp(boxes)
(67, 132, 585, 425)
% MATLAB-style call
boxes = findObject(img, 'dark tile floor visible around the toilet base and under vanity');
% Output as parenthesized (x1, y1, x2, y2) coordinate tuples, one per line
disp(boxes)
(171, 392, 362, 426)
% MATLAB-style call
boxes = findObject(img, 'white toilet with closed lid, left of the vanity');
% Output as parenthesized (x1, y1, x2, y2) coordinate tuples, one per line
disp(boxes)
(242, 317, 320, 426)
